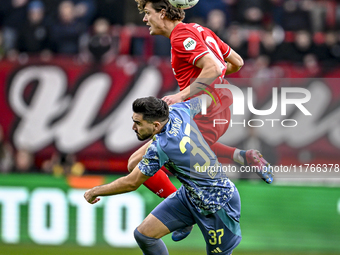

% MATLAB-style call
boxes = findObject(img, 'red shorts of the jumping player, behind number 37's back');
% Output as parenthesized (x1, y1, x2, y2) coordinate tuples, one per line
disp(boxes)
(194, 89, 233, 146)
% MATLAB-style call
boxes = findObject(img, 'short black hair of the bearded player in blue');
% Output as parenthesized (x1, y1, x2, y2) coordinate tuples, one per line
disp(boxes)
(132, 96, 169, 122)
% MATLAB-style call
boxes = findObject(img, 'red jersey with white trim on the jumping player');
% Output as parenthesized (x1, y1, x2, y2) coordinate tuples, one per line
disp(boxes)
(170, 23, 231, 90)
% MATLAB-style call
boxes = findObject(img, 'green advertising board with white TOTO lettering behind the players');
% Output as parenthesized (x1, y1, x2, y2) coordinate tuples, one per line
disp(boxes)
(0, 174, 340, 253)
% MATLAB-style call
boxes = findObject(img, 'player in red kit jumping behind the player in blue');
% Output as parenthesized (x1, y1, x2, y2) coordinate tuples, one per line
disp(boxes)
(128, 0, 273, 240)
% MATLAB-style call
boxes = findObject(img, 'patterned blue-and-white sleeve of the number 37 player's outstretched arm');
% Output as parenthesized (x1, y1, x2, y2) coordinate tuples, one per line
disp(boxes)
(137, 140, 162, 176)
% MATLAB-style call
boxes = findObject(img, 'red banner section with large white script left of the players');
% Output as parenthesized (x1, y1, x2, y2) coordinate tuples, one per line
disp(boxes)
(0, 56, 177, 171)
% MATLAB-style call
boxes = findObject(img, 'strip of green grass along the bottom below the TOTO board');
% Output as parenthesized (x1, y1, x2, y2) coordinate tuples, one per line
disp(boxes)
(0, 244, 338, 255)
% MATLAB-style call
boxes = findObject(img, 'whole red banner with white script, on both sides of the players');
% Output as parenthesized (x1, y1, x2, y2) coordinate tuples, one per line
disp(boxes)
(0, 56, 340, 172)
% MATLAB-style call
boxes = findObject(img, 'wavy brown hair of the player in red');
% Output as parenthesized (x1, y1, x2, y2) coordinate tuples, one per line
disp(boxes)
(135, 0, 185, 21)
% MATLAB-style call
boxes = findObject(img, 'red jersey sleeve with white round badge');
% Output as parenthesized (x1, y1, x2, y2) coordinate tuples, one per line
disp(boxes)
(171, 30, 209, 65)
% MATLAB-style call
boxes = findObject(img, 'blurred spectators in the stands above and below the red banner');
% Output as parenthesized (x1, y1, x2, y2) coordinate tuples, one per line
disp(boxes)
(0, 0, 340, 175)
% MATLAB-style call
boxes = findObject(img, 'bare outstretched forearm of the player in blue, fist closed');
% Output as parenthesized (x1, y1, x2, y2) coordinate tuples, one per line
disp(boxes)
(84, 167, 150, 204)
